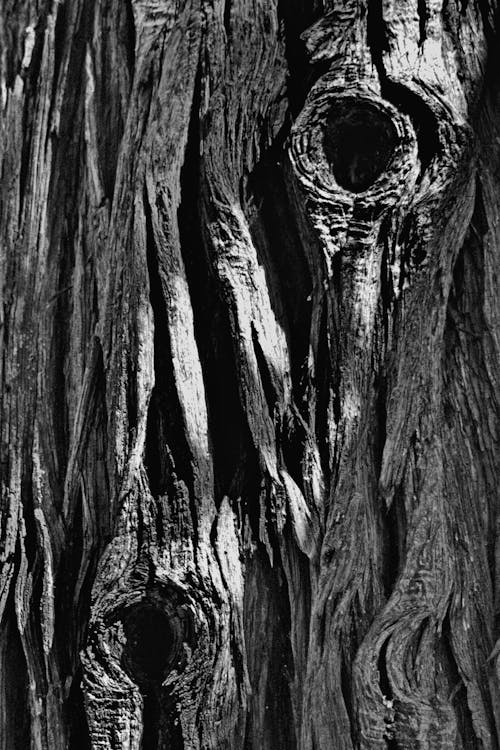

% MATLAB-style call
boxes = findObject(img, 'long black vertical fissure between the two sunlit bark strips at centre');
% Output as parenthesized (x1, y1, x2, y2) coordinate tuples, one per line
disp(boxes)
(177, 67, 258, 514)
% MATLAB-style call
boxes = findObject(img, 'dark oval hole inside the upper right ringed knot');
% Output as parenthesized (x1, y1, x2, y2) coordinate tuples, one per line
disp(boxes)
(323, 100, 398, 193)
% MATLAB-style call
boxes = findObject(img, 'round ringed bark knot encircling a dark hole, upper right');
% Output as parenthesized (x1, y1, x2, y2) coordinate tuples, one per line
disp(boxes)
(288, 82, 420, 212)
